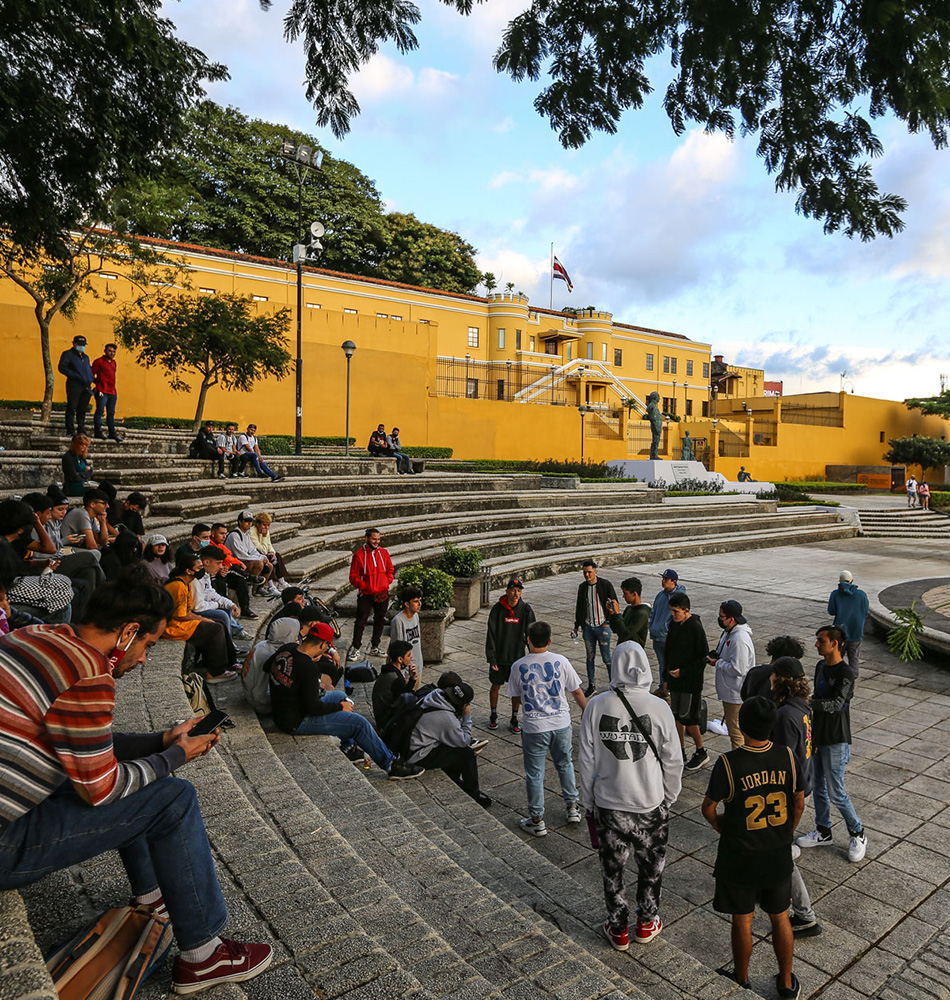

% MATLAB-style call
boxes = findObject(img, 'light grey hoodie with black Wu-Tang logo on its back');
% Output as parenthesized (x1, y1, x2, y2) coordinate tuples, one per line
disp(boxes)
(577, 640, 683, 813)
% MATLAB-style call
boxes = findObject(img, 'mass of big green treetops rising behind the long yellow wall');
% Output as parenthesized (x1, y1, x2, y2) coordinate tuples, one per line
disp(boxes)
(120, 101, 480, 292)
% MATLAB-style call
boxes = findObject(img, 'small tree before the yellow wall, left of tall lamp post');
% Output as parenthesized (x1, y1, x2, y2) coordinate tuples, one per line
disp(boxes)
(114, 293, 290, 433)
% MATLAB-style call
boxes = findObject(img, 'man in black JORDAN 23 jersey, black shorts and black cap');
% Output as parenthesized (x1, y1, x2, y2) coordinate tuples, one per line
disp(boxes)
(702, 697, 805, 1000)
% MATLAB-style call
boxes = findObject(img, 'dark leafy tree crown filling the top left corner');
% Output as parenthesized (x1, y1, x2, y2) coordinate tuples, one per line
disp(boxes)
(0, 0, 226, 258)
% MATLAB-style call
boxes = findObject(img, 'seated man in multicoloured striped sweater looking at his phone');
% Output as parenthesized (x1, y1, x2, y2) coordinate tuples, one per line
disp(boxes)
(0, 579, 273, 993)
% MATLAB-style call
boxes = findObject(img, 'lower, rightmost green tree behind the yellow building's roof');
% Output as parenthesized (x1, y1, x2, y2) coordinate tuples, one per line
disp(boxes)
(375, 212, 481, 292)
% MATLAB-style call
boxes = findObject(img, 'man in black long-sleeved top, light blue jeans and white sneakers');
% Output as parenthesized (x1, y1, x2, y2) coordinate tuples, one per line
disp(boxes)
(795, 625, 868, 863)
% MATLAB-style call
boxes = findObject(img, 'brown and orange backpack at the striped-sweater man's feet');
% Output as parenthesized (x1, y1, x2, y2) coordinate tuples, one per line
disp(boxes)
(46, 906, 172, 1000)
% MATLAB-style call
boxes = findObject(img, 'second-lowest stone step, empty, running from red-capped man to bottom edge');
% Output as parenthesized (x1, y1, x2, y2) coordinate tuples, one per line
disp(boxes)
(270, 734, 700, 1000)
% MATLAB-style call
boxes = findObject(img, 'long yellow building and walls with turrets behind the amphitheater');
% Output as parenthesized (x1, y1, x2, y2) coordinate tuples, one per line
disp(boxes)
(0, 232, 947, 480)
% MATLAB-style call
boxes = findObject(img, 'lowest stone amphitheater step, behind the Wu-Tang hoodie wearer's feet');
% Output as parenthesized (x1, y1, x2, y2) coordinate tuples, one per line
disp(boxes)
(380, 772, 760, 998)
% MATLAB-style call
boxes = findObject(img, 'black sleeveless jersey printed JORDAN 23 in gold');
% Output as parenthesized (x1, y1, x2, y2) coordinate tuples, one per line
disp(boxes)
(706, 743, 801, 886)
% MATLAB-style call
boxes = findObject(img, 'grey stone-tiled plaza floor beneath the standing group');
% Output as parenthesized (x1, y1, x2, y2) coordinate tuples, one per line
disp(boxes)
(344, 539, 950, 1000)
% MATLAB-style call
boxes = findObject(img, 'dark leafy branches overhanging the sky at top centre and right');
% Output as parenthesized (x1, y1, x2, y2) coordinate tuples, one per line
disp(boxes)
(259, 0, 950, 240)
